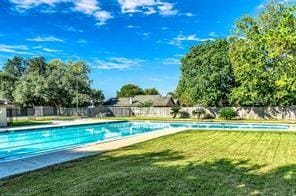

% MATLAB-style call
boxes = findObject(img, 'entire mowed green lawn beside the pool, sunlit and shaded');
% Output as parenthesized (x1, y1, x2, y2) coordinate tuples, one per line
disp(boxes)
(0, 131, 296, 196)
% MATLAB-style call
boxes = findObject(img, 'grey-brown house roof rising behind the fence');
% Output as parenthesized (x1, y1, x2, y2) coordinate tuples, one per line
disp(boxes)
(104, 95, 174, 107)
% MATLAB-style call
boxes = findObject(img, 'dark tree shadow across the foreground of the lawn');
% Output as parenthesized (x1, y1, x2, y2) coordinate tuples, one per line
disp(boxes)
(0, 147, 296, 195)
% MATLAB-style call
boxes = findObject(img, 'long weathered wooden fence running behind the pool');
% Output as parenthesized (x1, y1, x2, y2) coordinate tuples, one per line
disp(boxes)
(7, 106, 296, 120)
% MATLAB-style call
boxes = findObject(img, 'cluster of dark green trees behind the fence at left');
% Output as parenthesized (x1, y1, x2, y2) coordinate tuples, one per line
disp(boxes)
(0, 57, 104, 108)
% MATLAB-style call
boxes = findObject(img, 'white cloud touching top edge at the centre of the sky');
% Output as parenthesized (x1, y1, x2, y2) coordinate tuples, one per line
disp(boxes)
(118, 0, 178, 16)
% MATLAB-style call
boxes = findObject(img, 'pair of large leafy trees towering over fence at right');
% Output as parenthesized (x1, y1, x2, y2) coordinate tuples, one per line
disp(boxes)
(176, 1, 296, 106)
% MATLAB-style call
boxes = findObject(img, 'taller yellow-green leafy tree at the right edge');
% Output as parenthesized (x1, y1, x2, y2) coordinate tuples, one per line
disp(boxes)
(230, 2, 296, 106)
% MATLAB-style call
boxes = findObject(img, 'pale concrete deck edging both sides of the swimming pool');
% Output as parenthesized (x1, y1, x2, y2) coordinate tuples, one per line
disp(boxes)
(0, 120, 296, 179)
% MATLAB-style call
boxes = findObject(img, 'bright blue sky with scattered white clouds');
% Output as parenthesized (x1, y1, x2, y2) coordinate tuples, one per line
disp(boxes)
(0, 0, 266, 97)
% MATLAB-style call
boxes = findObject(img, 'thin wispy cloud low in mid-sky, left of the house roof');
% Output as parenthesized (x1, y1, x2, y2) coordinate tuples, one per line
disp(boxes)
(93, 57, 143, 70)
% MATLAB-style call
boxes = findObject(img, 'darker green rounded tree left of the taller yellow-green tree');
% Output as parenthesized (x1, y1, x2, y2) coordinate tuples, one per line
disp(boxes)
(177, 39, 234, 106)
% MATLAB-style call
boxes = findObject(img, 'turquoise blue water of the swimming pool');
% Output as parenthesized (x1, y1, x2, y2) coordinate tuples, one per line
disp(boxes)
(0, 122, 289, 162)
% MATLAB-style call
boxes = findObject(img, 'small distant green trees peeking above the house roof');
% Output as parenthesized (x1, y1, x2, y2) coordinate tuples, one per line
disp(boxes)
(117, 84, 159, 98)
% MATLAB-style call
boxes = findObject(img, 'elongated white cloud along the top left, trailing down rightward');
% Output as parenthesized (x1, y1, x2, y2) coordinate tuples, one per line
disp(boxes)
(9, 0, 113, 25)
